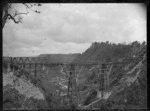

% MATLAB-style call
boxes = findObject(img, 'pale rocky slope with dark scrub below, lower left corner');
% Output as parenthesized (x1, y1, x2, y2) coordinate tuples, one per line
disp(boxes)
(3, 72, 48, 110)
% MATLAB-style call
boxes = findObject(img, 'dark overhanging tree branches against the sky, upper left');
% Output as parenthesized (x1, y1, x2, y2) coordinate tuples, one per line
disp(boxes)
(1, 0, 41, 28)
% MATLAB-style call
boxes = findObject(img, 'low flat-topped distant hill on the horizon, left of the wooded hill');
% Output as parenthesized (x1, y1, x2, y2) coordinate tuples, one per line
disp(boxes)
(38, 53, 80, 63)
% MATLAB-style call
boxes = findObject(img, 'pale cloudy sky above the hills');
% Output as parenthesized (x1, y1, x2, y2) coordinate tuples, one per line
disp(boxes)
(3, 3, 147, 57)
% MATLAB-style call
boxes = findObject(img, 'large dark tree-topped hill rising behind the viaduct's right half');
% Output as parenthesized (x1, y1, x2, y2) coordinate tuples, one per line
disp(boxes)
(74, 41, 146, 63)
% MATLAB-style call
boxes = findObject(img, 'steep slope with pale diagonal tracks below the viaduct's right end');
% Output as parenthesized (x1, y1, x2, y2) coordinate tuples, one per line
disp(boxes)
(78, 43, 147, 109)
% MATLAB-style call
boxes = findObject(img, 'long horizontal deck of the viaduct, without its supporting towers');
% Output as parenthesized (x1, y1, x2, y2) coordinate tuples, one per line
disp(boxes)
(3, 57, 139, 65)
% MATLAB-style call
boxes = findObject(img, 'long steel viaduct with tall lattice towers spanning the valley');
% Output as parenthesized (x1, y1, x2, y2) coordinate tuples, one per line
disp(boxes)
(3, 57, 141, 107)
